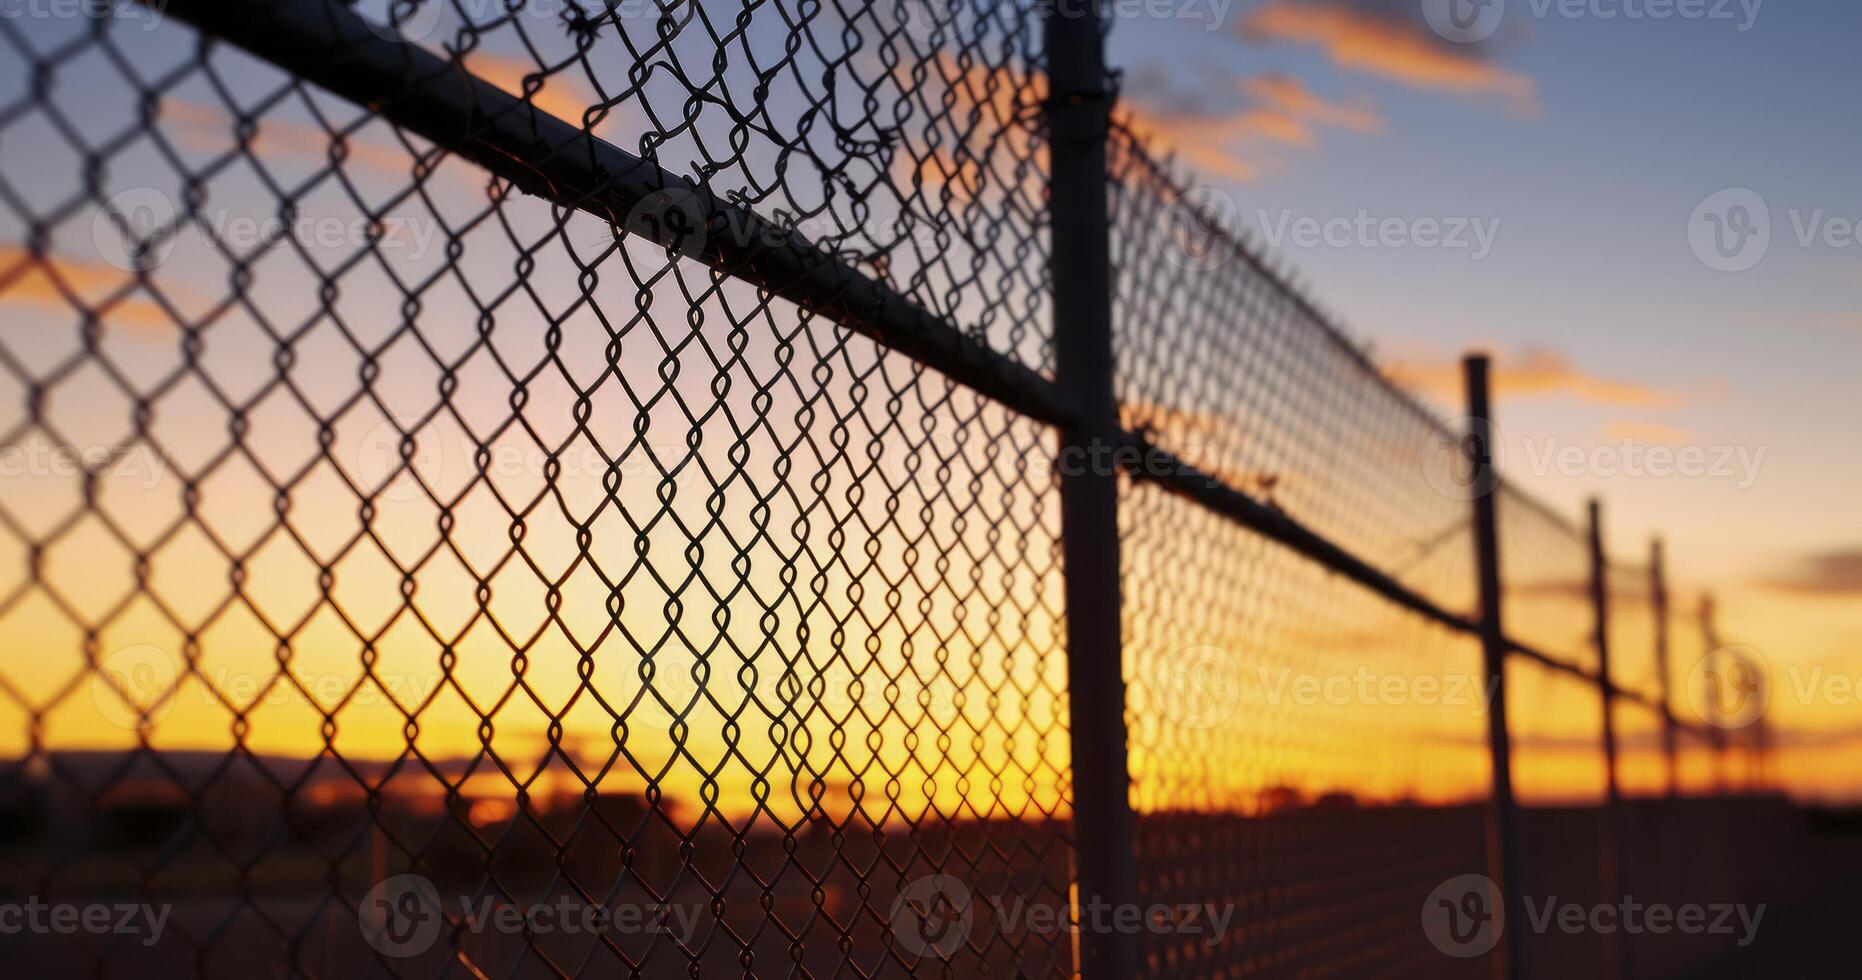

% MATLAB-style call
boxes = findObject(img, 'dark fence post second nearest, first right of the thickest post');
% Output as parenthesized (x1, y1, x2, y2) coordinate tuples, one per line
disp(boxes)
(1462, 356, 1527, 978)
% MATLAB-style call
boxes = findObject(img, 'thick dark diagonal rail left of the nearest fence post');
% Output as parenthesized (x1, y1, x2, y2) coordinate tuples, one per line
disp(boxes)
(152, 0, 1078, 434)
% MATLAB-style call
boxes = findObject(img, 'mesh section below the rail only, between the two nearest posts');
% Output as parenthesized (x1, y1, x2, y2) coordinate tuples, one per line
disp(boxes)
(1123, 486, 1491, 976)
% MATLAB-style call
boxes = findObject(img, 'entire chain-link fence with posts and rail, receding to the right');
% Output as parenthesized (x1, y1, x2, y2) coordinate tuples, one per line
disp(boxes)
(0, 0, 1763, 976)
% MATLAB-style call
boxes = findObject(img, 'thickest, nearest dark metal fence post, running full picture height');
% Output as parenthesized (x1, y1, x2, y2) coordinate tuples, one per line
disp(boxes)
(1043, 0, 1140, 980)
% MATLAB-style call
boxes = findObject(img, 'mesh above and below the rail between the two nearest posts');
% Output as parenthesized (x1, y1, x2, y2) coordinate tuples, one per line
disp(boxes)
(1112, 130, 1491, 976)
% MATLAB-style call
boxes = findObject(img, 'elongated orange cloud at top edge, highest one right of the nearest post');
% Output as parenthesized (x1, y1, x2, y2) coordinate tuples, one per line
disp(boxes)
(1242, 0, 1536, 104)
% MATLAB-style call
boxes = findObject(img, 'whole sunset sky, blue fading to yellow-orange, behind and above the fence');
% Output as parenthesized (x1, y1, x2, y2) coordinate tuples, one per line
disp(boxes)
(0, 0, 1862, 830)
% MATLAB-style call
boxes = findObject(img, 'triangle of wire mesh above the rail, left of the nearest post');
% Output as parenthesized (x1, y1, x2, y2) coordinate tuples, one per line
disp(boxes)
(340, 0, 1050, 367)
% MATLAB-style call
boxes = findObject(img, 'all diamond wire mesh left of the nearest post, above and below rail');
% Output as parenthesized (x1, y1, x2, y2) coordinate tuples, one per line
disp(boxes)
(0, 4, 1071, 976)
